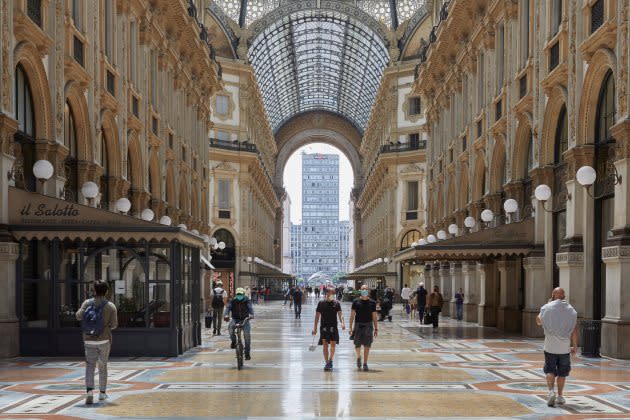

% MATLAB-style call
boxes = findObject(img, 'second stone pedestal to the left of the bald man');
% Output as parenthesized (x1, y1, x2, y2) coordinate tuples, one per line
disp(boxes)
(497, 260, 522, 332)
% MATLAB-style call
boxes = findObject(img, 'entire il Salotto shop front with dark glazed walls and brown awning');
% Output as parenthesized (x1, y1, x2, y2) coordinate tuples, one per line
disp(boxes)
(8, 188, 205, 356)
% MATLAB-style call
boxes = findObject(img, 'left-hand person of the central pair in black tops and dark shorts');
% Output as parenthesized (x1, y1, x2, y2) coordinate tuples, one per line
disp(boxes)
(313, 287, 346, 370)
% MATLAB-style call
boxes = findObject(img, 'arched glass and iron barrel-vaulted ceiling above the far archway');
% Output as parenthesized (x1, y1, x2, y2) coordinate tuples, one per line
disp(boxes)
(249, 9, 389, 133)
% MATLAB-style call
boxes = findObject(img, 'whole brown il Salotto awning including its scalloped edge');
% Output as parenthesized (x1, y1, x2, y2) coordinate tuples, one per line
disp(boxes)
(8, 187, 205, 248)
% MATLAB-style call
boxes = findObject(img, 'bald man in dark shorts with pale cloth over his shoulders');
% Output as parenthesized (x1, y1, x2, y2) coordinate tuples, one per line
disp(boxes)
(536, 287, 578, 407)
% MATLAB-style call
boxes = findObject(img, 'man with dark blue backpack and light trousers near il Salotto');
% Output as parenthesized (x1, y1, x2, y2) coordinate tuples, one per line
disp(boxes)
(76, 280, 118, 404)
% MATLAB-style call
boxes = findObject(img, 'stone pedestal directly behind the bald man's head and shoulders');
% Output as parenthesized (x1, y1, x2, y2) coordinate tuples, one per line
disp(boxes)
(556, 252, 592, 318)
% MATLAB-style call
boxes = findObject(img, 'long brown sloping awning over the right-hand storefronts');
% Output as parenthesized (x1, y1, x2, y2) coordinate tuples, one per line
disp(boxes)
(394, 218, 536, 262)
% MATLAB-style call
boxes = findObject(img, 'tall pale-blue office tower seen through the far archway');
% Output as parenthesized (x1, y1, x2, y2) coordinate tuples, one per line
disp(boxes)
(296, 153, 342, 280)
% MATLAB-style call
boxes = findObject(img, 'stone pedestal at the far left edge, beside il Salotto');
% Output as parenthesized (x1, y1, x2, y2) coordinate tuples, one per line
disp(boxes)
(0, 241, 20, 358)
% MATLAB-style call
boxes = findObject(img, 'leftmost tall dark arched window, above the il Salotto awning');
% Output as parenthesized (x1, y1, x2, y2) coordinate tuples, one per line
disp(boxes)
(13, 64, 35, 191)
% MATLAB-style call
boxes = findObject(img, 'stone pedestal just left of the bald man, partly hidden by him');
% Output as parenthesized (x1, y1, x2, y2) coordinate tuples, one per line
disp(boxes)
(523, 253, 548, 338)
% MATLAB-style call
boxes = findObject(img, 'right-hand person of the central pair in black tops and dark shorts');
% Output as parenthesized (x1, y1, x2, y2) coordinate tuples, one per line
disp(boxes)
(350, 284, 378, 371)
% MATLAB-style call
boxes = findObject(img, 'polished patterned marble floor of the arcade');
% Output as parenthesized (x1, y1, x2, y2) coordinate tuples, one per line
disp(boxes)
(0, 302, 630, 419)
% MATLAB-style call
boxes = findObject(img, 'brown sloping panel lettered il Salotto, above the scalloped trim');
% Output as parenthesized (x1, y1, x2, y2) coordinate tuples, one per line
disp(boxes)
(9, 188, 138, 226)
